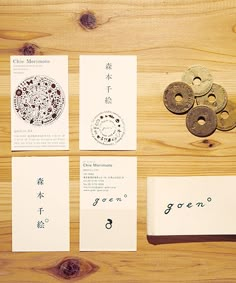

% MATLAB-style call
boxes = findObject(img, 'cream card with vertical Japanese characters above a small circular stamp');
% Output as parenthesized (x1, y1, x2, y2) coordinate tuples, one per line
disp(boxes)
(79, 55, 137, 150)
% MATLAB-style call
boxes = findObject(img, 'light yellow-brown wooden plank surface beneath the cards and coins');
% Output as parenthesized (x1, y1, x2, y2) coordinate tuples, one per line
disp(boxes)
(0, 0, 236, 283)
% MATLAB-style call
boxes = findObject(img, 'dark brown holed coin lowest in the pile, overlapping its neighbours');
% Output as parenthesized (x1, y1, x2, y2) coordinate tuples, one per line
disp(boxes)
(186, 105, 217, 137)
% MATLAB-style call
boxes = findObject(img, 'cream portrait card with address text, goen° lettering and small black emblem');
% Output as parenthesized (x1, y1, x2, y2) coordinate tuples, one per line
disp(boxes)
(80, 157, 137, 251)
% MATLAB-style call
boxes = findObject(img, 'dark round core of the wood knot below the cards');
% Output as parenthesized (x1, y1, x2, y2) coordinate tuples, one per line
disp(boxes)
(58, 259, 80, 279)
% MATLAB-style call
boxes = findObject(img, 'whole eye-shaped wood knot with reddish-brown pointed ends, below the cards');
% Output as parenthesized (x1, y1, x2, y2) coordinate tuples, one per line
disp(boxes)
(44, 257, 99, 279)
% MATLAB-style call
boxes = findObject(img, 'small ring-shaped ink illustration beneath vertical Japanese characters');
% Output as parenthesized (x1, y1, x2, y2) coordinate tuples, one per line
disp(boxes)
(91, 111, 125, 145)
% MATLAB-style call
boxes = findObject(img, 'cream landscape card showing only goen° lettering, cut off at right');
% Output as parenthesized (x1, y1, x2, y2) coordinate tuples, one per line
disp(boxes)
(147, 176, 236, 236)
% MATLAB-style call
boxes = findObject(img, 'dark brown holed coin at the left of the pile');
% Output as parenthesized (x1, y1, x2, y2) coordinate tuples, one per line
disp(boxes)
(163, 82, 194, 114)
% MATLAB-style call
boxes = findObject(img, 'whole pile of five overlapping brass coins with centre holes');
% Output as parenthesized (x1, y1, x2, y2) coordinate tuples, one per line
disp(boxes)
(163, 65, 236, 137)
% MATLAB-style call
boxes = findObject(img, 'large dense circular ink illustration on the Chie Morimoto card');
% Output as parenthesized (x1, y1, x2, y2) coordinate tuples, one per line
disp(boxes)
(14, 75, 65, 126)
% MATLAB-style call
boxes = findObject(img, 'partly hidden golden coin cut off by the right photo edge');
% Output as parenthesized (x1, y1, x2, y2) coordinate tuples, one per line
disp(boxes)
(217, 100, 236, 131)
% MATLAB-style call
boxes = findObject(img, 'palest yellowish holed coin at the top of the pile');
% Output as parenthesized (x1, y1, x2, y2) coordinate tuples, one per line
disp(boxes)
(182, 65, 213, 96)
